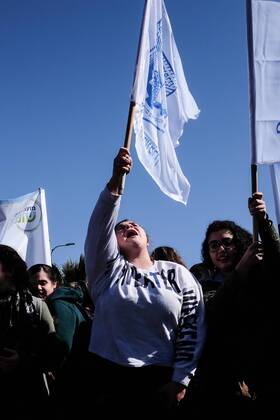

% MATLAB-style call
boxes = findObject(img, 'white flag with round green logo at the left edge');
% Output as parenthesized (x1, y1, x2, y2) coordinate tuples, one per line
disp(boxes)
(0, 188, 51, 267)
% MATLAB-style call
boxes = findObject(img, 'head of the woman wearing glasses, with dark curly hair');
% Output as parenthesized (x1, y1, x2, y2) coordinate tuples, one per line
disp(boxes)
(201, 220, 252, 273)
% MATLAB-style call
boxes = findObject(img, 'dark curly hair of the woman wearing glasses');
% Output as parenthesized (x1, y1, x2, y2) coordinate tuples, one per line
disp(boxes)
(201, 220, 253, 270)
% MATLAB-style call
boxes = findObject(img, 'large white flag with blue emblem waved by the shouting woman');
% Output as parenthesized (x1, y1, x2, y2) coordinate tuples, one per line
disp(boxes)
(132, 0, 199, 204)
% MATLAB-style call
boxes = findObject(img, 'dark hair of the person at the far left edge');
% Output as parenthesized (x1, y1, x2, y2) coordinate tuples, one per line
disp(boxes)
(0, 245, 28, 290)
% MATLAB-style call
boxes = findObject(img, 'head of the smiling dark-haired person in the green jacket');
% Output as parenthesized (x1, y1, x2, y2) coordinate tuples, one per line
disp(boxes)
(28, 264, 59, 299)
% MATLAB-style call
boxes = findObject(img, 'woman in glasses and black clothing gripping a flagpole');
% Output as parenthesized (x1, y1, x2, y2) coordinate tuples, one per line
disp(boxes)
(189, 193, 280, 419)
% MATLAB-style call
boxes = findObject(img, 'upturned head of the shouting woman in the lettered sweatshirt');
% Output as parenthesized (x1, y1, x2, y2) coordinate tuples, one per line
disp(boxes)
(115, 219, 149, 259)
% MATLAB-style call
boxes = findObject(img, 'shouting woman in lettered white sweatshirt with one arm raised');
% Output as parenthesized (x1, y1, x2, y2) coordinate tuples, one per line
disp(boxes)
(85, 148, 204, 415)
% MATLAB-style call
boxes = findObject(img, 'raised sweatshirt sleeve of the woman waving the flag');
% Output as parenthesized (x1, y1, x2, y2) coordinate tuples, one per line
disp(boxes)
(85, 187, 121, 288)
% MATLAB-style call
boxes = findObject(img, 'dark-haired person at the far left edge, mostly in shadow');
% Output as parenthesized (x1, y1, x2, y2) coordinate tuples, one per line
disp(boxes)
(0, 245, 60, 419)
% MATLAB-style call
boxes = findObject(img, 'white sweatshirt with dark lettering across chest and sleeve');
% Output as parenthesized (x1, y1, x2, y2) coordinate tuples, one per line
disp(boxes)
(85, 188, 204, 385)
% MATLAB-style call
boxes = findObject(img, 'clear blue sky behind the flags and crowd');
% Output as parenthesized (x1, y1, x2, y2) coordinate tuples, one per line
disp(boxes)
(0, 0, 275, 266)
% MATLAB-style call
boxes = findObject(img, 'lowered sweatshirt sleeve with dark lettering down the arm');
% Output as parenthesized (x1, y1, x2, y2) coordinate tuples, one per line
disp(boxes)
(172, 272, 205, 386)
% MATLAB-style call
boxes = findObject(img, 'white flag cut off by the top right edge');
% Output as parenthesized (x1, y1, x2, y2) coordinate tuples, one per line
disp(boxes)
(247, 0, 280, 164)
